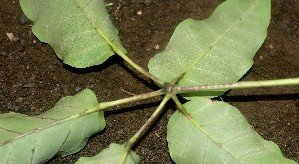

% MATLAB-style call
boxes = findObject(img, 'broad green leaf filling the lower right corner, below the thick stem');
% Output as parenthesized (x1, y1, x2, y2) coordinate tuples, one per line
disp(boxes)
(167, 98, 295, 164)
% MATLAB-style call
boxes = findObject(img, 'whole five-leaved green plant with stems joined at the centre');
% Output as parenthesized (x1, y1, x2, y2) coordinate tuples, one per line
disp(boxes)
(0, 0, 299, 163)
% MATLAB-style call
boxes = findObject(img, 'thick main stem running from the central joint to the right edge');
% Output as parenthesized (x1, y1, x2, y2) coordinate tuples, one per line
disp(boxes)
(169, 78, 299, 94)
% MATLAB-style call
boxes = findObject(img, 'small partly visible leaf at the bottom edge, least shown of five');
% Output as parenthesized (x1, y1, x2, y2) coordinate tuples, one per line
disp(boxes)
(76, 143, 140, 164)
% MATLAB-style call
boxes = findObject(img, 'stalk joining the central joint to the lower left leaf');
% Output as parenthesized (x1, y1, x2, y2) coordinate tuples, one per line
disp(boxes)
(84, 89, 165, 115)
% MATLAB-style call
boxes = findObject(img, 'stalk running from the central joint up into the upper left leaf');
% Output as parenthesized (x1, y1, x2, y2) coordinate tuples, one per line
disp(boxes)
(96, 28, 166, 86)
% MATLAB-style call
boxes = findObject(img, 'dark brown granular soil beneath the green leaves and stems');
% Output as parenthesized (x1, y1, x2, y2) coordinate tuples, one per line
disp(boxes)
(0, 0, 299, 163)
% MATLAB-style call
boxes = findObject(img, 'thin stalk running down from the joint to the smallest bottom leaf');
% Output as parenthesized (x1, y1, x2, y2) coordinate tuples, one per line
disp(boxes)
(121, 94, 172, 163)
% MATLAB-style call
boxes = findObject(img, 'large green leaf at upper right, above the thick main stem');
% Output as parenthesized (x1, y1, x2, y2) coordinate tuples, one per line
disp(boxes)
(148, 0, 271, 96)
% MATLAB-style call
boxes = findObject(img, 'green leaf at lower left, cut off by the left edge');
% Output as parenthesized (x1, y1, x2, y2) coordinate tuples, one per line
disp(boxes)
(0, 89, 105, 163)
